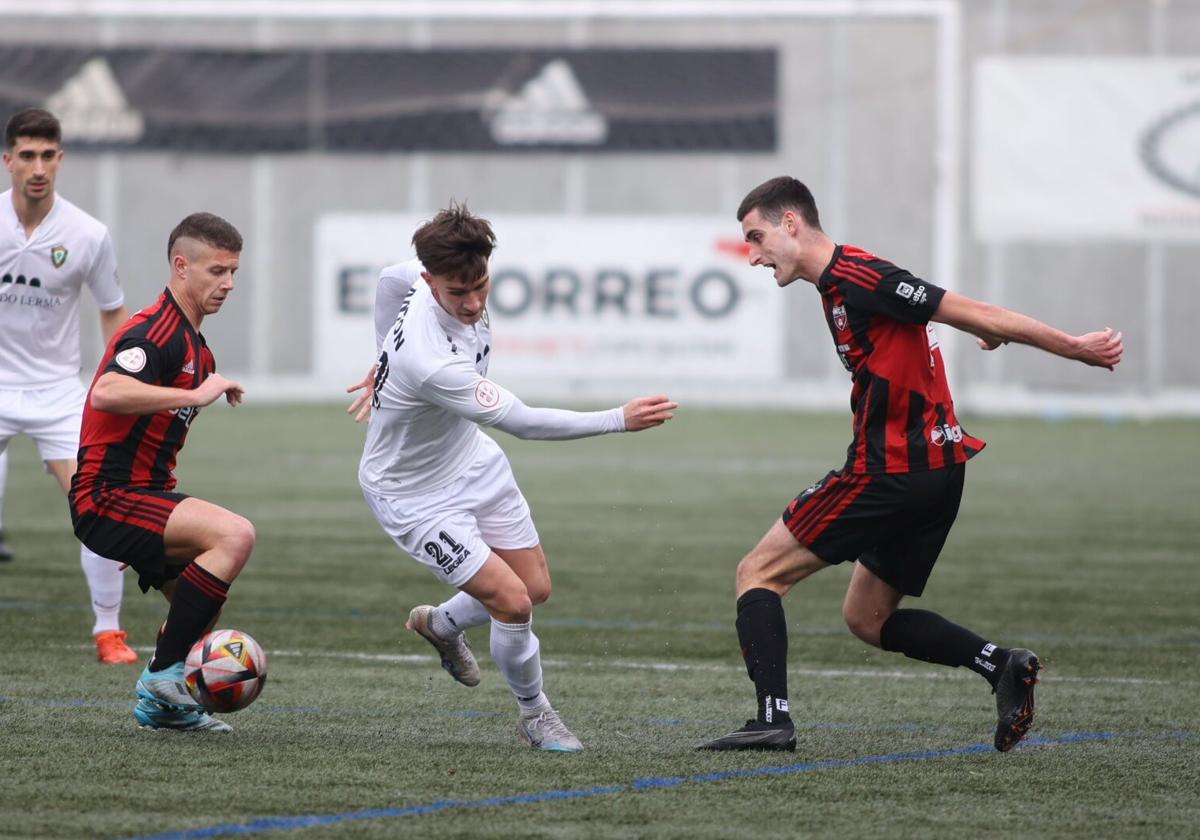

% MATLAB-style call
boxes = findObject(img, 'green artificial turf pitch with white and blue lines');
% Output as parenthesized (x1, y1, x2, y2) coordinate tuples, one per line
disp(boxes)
(0, 403, 1200, 840)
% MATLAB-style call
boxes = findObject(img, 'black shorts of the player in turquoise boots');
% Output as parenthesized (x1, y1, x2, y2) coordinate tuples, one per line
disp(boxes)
(71, 486, 190, 592)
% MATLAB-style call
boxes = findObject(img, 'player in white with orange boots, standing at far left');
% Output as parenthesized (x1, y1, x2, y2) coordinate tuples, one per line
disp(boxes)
(0, 108, 138, 665)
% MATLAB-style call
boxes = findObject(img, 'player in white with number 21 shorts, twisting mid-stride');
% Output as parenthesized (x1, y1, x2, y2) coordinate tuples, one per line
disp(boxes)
(348, 205, 677, 752)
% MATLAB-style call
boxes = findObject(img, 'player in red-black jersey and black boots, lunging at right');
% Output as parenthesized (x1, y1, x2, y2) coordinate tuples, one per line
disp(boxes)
(700, 176, 1122, 751)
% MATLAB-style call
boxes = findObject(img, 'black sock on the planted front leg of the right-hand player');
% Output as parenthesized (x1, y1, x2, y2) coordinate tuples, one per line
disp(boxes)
(737, 589, 792, 725)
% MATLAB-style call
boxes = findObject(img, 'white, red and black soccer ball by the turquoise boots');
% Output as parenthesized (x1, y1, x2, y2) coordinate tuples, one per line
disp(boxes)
(184, 630, 266, 712)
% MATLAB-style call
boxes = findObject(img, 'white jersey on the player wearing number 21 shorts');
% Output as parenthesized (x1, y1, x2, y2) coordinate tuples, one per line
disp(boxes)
(359, 259, 515, 496)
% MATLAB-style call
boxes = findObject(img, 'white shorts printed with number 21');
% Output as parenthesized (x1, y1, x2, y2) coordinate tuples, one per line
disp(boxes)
(362, 438, 541, 588)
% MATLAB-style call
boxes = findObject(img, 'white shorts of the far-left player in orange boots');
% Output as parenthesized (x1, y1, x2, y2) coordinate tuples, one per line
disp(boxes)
(0, 379, 88, 461)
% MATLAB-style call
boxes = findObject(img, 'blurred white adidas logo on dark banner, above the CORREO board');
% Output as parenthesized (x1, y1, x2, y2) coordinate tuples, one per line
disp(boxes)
(485, 59, 608, 145)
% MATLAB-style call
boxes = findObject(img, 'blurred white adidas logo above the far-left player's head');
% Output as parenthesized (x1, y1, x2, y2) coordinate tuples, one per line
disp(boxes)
(46, 58, 145, 143)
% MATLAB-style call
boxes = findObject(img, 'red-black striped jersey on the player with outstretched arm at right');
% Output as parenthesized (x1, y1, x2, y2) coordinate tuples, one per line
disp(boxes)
(817, 245, 985, 474)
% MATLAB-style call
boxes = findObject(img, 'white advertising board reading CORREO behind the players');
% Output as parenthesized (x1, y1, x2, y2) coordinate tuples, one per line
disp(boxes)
(313, 214, 784, 391)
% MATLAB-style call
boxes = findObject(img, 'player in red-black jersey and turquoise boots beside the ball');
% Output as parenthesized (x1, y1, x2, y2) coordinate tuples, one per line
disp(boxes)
(70, 212, 254, 732)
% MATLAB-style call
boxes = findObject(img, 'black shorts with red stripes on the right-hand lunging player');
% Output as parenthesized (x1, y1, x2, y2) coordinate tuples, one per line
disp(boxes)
(784, 464, 966, 595)
